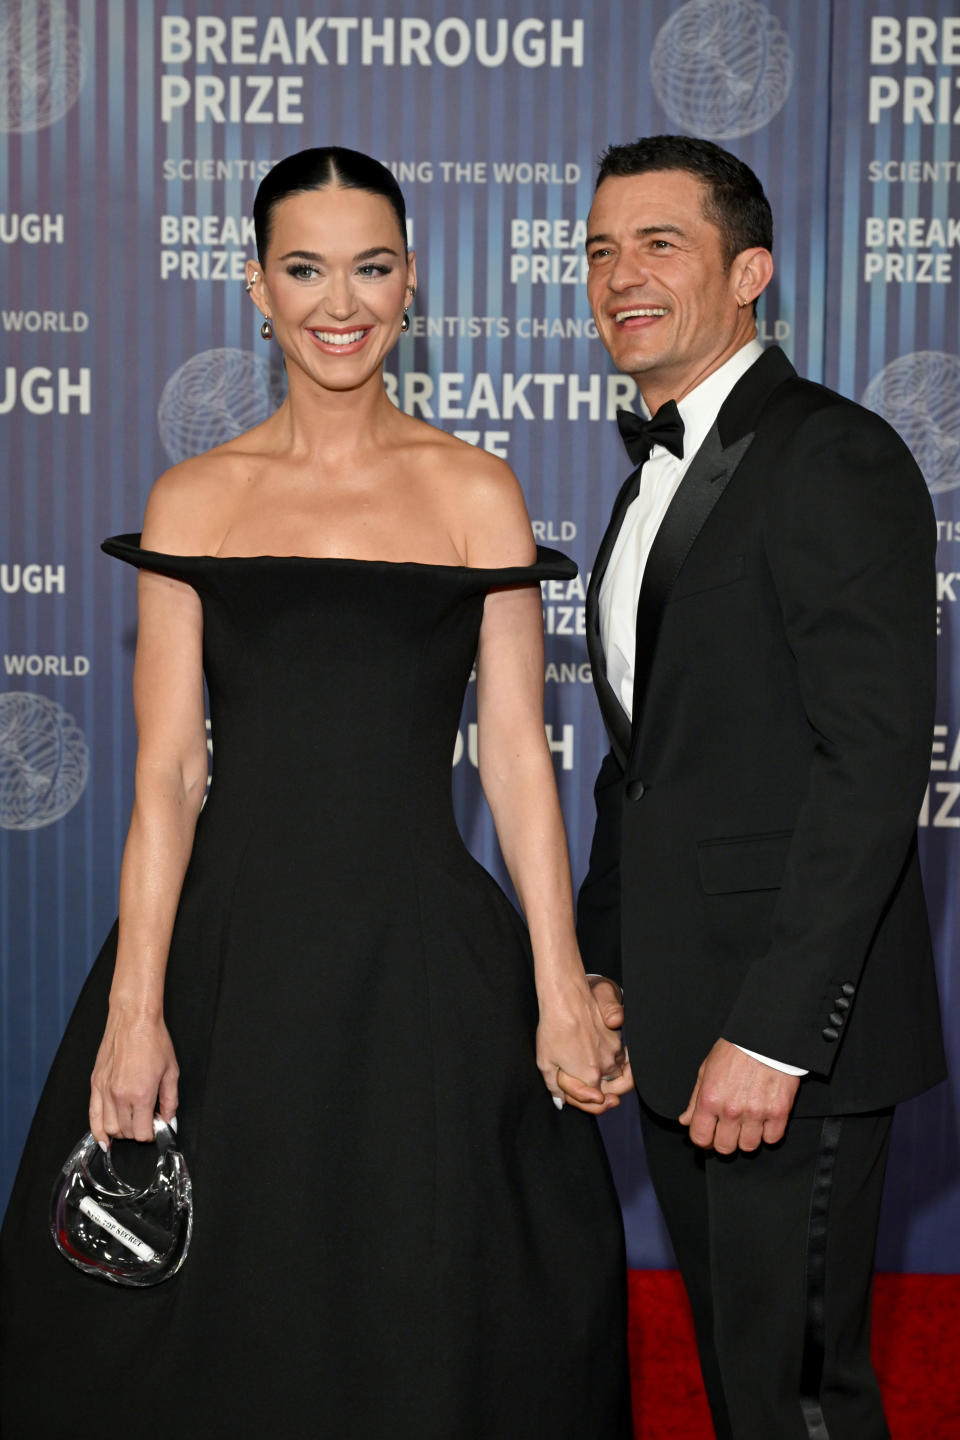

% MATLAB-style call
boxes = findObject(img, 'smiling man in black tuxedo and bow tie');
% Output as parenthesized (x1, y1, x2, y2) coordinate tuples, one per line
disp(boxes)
(570, 135, 944, 1440)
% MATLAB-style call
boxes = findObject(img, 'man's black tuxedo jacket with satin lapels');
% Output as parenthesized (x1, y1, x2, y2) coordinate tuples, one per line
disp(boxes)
(579, 348, 944, 1116)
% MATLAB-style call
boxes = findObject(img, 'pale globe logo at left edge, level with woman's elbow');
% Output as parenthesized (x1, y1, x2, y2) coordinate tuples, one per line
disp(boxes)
(0, 690, 89, 829)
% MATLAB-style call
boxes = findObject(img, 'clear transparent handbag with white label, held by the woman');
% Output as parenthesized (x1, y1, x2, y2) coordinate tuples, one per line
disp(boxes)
(50, 1116, 193, 1286)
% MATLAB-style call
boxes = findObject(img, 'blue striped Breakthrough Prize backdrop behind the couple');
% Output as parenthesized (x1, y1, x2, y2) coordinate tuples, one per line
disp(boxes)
(0, 0, 960, 1270)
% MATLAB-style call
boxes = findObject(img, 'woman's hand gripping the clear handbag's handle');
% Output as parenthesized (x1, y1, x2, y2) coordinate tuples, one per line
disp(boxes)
(91, 1009, 180, 1146)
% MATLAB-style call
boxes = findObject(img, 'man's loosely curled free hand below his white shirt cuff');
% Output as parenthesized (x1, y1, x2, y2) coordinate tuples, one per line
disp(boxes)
(679, 1040, 800, 1155)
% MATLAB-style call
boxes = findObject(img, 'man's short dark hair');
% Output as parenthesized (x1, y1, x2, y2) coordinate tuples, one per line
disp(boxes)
(597, 135, 773, 268)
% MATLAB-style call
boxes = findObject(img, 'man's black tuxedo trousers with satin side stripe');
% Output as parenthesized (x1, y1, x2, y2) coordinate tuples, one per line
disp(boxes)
(640, 1100, 894, 1440)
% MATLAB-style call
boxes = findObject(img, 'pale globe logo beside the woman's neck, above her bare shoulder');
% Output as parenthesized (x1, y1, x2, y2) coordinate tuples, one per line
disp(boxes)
(157, 350, 286, 464)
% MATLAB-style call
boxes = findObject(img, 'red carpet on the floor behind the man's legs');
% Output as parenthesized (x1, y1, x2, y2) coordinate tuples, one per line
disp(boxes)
(630, 1270, 960, 1440)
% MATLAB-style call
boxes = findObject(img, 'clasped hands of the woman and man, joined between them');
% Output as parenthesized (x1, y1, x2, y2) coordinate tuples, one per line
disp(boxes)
(537, 976, 633, 1115)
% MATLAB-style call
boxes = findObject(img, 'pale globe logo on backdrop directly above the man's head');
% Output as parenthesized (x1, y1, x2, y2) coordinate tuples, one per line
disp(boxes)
(651, 0, 793, 140)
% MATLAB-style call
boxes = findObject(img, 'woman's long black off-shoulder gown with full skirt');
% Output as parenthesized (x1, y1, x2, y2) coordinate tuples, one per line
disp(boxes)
(0, 536, 632, 1440)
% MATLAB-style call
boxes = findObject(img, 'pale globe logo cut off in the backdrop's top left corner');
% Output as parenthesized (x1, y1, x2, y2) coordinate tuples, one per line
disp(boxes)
(0, 0, 86, 134)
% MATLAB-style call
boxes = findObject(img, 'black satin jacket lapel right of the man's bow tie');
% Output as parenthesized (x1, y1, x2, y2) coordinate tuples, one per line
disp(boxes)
(630, 425, 753, 759)
